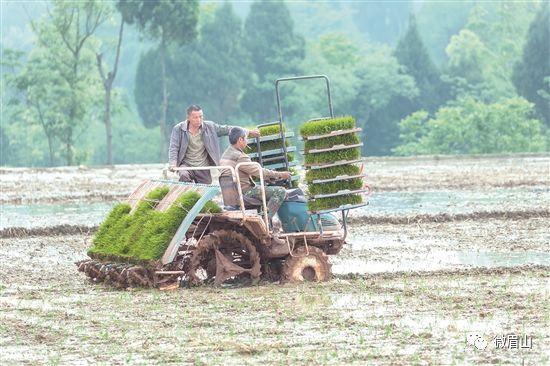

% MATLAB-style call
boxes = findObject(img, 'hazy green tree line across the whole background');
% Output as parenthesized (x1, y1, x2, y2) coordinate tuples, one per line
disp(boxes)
(0, 0, 550, 166)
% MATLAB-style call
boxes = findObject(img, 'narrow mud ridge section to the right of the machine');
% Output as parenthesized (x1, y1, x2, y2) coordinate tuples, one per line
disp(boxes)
(348, 210, 550, 225)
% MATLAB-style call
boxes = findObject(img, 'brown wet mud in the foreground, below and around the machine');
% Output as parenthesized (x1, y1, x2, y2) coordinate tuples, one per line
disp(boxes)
(0, 235, 550, 365)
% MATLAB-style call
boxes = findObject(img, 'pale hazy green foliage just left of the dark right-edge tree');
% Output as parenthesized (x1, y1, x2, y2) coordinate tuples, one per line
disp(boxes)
(445, 2, 538, 103)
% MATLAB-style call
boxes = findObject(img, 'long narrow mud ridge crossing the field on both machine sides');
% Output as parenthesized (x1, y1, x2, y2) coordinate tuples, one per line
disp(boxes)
(0, 210, 550, 238)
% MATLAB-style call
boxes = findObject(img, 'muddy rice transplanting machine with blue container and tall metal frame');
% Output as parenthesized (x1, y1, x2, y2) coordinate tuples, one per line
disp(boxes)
(77, 76, 368, 289)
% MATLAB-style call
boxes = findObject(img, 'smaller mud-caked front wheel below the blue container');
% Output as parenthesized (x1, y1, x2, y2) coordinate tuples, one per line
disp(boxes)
(283, 246, 331, 282)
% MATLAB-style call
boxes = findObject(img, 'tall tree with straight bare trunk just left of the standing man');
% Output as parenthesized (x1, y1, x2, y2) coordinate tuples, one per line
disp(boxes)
(117, 0, 198, 161)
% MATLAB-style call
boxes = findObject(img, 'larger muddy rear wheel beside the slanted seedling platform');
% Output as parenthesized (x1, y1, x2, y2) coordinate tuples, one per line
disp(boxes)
(189, 230, 261, 285)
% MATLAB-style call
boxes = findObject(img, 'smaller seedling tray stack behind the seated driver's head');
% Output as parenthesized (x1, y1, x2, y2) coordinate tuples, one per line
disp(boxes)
(245, 122, 299, 187)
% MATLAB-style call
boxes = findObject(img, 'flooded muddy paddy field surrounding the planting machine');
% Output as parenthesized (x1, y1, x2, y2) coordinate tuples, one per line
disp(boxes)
(0, 155, 550, 365)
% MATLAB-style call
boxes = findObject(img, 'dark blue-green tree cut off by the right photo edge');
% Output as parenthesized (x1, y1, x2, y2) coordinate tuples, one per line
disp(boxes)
(512, 3, 550, 127)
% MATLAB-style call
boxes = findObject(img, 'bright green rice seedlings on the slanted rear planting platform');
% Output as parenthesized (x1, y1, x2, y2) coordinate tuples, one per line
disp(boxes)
(88, 187, 221, 265)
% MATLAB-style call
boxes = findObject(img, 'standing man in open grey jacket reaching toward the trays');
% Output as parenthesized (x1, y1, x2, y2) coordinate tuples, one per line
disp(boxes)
(168, 105, 260, 184)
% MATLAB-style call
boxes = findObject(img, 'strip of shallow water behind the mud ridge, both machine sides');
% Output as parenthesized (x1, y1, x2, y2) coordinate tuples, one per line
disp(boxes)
(0, 187, 550, 230)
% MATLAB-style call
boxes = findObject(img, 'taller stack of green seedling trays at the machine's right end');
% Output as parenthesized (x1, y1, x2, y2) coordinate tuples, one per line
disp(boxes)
(300, 117, 368, 212)
